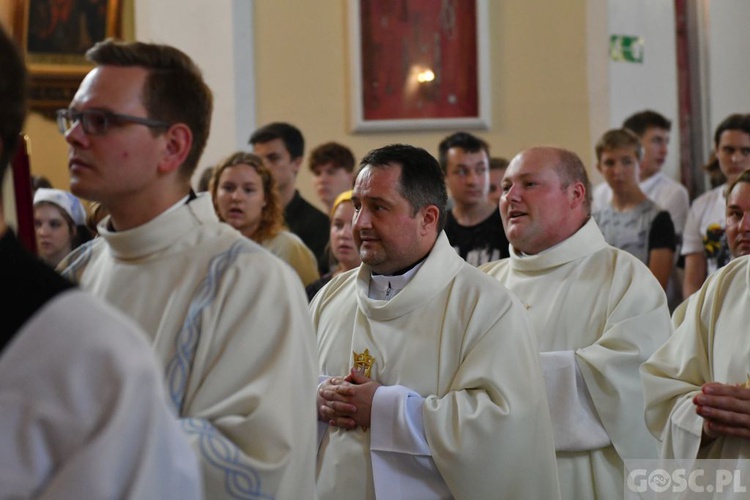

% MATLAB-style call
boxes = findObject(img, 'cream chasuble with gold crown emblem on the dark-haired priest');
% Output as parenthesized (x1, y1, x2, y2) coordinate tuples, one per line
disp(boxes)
(310, 233, 558, 500)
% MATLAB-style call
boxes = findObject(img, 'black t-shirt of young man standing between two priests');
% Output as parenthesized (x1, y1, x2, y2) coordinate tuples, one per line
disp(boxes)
(445, 208, 510, 266)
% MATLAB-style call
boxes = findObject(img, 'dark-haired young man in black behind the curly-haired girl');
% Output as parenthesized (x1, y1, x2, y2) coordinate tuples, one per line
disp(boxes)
(250, 122, 330, 275)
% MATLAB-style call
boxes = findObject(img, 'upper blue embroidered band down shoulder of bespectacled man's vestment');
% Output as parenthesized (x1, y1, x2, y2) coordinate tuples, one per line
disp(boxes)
(166, 240, 247, 415)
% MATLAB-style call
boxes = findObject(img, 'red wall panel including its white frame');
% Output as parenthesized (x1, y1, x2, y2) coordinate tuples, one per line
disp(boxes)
(348, 0, 491, 132)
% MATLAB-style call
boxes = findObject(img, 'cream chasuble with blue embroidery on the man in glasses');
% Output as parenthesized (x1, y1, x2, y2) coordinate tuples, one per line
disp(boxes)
(58, 194, 317, 499)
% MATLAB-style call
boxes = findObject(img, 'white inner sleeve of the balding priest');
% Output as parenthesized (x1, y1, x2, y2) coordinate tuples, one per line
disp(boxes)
(539, 351, 610, 451)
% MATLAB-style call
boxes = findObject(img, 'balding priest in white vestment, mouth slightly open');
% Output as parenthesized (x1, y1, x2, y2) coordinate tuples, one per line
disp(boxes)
(481, 147, 671, 500)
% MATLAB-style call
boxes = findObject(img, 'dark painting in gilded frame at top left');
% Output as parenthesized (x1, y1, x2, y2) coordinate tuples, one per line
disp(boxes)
(14, 0, 121, 116)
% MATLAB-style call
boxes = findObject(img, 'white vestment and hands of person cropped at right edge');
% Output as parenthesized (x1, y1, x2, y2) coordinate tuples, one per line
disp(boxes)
(641, 256, 750, 462)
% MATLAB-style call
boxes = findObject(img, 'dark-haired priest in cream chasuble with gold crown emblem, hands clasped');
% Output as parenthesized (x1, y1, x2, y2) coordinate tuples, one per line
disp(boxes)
(310, 145, 559, 500)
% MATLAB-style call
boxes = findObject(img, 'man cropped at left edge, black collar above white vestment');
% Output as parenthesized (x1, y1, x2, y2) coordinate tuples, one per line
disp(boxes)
(0, 26, 203, 500)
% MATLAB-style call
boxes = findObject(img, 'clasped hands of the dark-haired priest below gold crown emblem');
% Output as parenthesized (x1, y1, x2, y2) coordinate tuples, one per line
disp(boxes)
(318, 368, 381, 430)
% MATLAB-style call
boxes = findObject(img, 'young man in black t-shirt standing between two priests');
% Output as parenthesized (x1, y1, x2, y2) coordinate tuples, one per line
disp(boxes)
(438, 132, 509, 266)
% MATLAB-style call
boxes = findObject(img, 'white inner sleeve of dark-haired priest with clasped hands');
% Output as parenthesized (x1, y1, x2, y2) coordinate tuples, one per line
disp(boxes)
(370, 385, 451, 498)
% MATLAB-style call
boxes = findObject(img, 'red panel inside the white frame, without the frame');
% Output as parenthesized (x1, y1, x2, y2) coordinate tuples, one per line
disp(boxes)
(359, 0, 479, 121)
